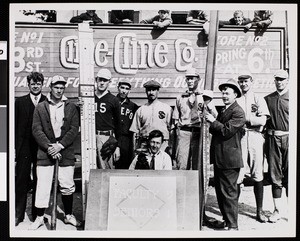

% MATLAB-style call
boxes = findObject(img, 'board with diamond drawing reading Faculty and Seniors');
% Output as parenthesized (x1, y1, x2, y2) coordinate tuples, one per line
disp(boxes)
(85, 169, 200, 231)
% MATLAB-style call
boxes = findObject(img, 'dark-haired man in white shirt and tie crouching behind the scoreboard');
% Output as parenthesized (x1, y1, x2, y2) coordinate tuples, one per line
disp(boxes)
(129, 130, 172, 170)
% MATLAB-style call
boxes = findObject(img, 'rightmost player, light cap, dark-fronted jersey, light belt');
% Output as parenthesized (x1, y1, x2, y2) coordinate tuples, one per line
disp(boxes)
(265, 70, 289, 222)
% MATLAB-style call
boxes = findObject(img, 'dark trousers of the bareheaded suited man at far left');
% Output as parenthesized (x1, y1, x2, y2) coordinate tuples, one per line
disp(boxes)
(15, 155, 37, 221)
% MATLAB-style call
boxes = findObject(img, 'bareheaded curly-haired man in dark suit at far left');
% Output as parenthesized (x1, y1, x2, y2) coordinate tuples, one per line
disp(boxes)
(15, 72, 46, 226)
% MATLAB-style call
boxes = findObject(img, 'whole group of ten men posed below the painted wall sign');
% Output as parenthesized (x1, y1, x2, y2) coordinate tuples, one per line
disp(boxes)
(15, 65, 289, 230)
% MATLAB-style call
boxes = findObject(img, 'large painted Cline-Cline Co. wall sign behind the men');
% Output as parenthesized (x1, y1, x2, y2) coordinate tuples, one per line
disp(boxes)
(14, 23, 285, 105)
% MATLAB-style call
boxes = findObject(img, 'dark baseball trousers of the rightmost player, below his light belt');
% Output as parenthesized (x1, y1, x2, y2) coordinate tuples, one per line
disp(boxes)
(265, 135, 289, 198)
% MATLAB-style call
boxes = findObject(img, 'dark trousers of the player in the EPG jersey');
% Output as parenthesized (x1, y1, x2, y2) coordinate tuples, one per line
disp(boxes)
(115, 135, 133, 169)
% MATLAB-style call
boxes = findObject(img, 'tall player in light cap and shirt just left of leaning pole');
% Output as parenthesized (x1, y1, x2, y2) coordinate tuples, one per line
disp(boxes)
(173, 68, 217, 170)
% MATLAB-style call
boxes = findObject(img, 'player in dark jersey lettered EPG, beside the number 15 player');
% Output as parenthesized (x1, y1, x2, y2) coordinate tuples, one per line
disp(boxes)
(116, 80, 138, 169)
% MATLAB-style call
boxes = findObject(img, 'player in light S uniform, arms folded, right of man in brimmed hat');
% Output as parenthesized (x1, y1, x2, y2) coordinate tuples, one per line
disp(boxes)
(237, 72, 270, 223)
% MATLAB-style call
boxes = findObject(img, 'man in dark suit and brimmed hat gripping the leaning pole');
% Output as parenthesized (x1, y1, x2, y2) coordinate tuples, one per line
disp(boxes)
(205, 79, 246, 230)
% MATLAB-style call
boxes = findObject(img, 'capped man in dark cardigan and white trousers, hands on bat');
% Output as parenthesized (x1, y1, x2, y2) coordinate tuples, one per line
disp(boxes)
(29, 75, 80, 230)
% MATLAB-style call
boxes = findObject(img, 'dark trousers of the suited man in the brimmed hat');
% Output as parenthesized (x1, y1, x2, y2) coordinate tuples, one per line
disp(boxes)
(214, 165, 240, 228)
